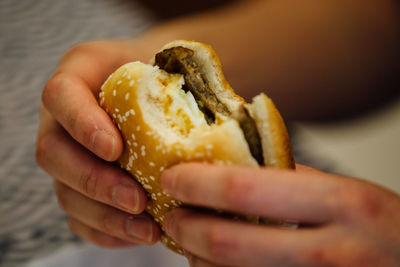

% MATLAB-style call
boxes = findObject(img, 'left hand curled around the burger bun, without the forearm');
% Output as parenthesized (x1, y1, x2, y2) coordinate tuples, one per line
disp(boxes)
(36, 41, 160, 247)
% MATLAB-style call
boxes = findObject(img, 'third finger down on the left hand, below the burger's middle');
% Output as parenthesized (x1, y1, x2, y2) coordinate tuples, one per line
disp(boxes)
(54, 182, 160, 244)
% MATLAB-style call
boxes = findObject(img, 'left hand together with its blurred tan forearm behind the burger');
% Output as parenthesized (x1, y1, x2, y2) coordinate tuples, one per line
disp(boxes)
(36, 0, 399, 262)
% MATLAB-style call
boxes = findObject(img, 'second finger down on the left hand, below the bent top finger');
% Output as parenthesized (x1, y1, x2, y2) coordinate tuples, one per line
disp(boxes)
(36, 108, 147, 214)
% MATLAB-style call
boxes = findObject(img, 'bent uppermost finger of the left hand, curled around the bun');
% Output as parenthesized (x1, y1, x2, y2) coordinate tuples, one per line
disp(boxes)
(42, 41, 139, 161)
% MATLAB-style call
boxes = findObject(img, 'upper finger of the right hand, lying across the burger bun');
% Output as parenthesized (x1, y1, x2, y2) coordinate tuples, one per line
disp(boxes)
(162, 163, 342, 223)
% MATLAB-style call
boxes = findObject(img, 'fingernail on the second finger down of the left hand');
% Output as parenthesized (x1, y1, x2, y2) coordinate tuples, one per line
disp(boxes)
(112, 184, 140, 214)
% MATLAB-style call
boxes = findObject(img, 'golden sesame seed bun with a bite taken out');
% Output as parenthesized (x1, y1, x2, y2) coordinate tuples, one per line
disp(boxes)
(99, 41, 294, 254)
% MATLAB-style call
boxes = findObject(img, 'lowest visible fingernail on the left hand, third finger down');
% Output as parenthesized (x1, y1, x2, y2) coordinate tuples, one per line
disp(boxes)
(126, 215, 153, 244)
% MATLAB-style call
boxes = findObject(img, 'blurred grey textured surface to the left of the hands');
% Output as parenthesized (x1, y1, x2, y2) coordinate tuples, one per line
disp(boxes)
(0, 0, 154, 266)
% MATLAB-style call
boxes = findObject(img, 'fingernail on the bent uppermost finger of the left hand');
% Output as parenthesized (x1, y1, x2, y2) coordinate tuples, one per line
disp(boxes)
(90, 130, 116, 161)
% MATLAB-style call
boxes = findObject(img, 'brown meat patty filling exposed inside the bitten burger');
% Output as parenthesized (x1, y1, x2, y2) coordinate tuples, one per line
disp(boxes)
(155, 46, 264, 165)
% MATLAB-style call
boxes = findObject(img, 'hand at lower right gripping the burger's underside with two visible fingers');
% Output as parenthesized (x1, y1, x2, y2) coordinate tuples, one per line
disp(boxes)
(162, 163, 400, 266)
